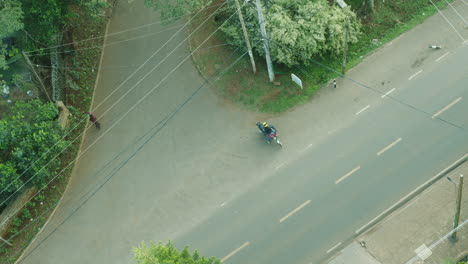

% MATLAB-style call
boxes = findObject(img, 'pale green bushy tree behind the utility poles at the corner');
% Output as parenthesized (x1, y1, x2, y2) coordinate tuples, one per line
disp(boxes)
(222, 0, 360, 66)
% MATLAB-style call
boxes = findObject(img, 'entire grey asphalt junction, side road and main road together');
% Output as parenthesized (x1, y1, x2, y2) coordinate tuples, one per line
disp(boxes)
(22, 1, 468, 264)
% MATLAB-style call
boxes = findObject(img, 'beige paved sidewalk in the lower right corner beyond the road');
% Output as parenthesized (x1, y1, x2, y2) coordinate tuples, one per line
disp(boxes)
(328, 159, 468, 264)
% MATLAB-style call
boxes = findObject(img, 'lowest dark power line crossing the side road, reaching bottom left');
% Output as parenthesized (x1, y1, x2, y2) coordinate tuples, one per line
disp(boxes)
(12, 41, 252, 263)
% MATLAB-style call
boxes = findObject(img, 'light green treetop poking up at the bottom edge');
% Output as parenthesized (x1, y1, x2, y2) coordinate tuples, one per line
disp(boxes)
(133, 241, 221, 264)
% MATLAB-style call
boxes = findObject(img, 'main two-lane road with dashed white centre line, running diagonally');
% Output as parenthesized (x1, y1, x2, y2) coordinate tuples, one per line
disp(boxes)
(172, 44, 468, 263)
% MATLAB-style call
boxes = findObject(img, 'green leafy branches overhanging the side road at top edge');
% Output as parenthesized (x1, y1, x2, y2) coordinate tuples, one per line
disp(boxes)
(145, 0, 212, 20)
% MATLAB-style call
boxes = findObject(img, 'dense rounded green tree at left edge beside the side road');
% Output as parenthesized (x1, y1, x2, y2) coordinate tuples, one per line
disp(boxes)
(0, 100, 67, 204)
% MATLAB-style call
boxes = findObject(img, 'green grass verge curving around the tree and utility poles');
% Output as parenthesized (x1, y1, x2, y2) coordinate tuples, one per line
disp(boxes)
(189, 0, 455, 112)
